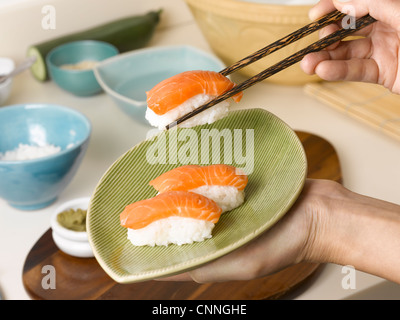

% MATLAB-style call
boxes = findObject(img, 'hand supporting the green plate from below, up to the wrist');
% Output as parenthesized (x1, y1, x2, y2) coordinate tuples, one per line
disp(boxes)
(164, 180, 337, 283)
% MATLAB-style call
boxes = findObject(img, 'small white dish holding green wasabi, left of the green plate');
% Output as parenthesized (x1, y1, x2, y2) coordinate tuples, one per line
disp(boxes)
(50, 197, 94, 258)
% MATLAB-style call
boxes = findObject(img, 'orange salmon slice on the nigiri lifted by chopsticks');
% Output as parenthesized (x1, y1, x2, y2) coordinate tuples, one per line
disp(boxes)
(146, 70, 243, 115)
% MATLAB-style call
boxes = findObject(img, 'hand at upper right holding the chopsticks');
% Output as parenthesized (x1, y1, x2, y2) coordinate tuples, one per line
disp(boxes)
(301, 0, 400, 94)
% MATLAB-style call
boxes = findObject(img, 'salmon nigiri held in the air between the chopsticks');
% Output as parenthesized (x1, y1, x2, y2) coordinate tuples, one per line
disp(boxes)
(145, 70, 243, 130)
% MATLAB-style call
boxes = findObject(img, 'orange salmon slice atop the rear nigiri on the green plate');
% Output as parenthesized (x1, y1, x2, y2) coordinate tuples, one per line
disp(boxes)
(150, 164, 248, 193)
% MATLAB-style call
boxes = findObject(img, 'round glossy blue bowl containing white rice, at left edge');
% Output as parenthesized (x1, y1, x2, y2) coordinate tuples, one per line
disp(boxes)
(0, 104, 91, 210)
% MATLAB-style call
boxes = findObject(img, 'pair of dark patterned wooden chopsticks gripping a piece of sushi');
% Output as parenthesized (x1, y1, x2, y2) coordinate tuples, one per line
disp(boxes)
(166, 11, 376, 130)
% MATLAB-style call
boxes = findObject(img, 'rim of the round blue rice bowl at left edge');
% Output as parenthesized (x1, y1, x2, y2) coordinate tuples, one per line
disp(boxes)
(0, 103, 92, 165)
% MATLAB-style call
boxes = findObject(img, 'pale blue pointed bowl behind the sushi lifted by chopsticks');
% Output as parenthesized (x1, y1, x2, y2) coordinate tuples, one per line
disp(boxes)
(94, 46, 225, 125)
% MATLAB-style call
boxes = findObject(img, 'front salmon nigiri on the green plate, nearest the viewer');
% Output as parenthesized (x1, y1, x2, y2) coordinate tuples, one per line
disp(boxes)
(120, 191, 222, 246)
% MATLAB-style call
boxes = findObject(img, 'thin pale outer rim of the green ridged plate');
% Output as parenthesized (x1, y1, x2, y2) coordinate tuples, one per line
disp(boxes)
(87, 109, 308, 284)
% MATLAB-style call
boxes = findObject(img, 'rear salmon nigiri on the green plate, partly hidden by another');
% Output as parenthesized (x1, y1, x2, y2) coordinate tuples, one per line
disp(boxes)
(149, 164, 248, 212)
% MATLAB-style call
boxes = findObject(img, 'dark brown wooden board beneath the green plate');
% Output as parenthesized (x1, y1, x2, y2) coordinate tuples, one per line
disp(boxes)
(22, 132, 342, 300)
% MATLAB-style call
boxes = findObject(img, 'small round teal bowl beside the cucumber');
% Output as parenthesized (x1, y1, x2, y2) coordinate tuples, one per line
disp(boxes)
(46, 40, 119, 97)
